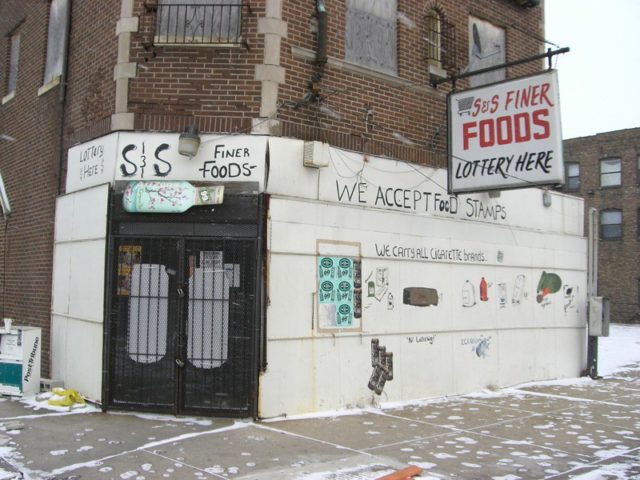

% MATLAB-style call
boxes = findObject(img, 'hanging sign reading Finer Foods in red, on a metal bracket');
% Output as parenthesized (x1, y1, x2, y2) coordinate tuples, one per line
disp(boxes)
(448, 70, 564, 193)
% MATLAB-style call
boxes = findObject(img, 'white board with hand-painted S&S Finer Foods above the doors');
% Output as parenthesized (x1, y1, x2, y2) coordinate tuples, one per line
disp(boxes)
(115, 132, 267, 189)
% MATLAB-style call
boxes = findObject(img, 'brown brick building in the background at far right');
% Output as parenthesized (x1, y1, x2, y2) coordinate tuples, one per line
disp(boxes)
(562, 128, 640, 323)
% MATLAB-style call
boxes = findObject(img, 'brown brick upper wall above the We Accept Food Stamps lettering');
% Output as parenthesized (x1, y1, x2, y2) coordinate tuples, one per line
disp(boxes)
(280, 0, 543, 166)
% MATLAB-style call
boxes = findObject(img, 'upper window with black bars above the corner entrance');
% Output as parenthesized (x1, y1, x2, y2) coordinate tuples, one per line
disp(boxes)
(154, 0, 242, 45)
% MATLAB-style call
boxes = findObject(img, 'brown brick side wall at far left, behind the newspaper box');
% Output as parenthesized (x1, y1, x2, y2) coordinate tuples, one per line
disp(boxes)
(0, 0, 62, 376)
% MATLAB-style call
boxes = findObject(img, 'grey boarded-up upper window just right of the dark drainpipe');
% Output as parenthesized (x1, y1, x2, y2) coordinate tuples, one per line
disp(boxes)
(345, 0, 398, 75)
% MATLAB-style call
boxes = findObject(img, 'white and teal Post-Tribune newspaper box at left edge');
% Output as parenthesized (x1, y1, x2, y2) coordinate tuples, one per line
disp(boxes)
(0, 321, 42, 396)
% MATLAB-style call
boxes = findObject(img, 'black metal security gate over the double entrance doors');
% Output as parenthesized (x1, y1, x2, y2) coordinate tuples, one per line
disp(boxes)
(104, 194, 259, 416)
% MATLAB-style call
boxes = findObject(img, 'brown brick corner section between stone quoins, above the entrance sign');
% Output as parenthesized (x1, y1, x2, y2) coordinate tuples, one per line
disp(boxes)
(129, 0, 264, 133)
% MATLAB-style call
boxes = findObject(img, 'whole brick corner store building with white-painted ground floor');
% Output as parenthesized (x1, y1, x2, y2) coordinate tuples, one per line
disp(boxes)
(0, 0, 586, 416)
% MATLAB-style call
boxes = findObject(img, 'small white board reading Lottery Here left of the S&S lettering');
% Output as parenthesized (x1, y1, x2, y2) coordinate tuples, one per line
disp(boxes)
(66, 133, 118, 193)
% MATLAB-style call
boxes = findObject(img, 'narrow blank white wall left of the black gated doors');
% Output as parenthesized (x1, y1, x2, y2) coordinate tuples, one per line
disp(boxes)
(51, 184, 109, 400)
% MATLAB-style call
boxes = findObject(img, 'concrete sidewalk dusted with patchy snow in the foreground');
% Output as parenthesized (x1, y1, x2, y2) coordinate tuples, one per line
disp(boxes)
(0, 366, 640, 480)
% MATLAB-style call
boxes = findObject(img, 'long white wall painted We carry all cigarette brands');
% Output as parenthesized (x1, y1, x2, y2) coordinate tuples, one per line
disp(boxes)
(259, 139, 586, 417)
